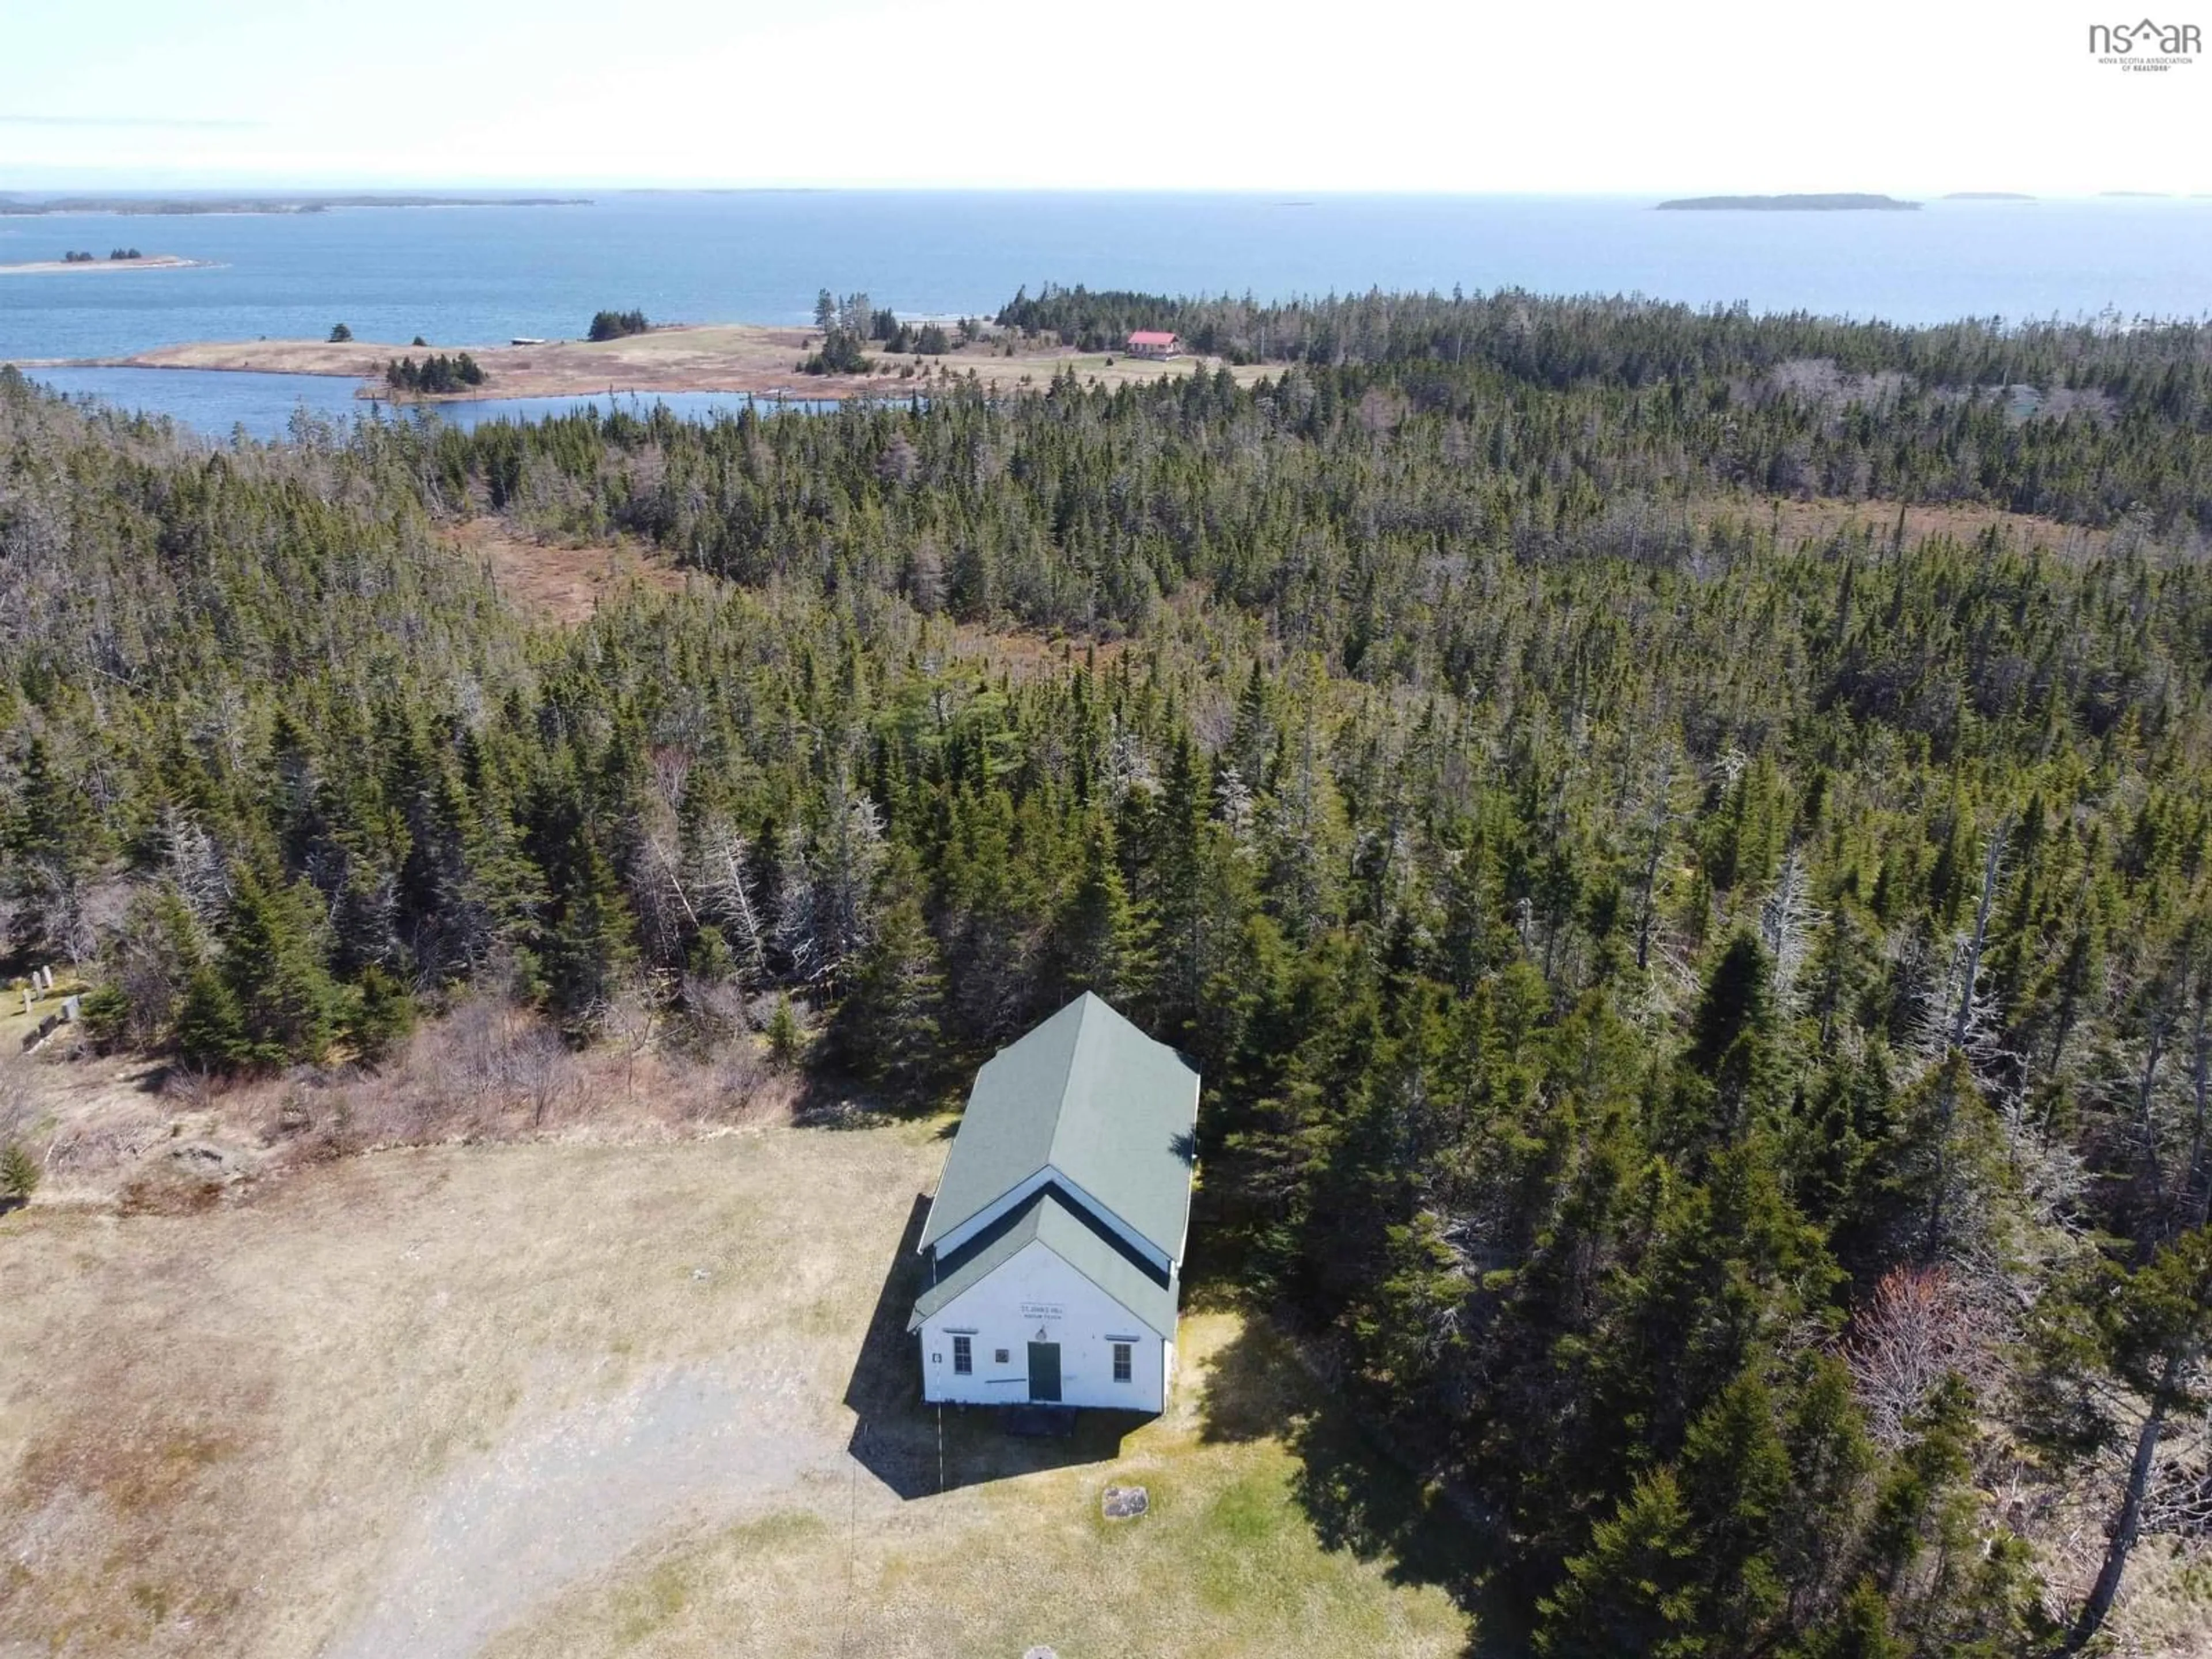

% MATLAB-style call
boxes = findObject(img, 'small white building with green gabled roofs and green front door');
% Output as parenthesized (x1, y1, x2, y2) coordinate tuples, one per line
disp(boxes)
(907, 991, 1199, 1411)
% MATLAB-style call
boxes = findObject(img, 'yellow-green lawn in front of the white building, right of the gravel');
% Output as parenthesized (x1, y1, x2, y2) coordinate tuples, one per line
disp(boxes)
(491, 1314, 1475, 1659)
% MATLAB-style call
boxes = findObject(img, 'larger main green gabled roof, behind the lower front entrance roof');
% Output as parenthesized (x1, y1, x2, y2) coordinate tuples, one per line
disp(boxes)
(922, 991, 1199, 1261)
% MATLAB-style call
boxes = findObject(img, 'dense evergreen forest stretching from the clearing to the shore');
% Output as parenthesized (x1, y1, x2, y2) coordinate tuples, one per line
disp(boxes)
(0, 287, 2212, 1659)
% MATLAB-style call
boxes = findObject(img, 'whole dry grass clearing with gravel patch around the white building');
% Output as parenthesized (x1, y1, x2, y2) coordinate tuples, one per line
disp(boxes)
(0, 1122, 1469, 1659)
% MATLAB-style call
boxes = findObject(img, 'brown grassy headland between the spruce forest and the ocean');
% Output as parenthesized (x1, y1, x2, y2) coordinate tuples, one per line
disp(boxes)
(35, 323, 1267, 398)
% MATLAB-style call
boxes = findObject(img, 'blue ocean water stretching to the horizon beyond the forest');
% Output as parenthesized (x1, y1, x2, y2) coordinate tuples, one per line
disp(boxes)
(0, 190, 2212, 429)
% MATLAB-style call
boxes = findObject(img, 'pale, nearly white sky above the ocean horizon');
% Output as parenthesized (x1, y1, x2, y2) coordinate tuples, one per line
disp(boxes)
(0, 0, 2212, 195)
